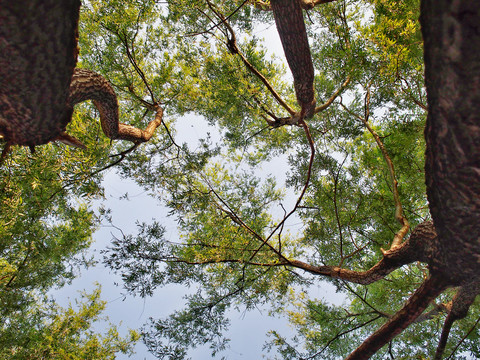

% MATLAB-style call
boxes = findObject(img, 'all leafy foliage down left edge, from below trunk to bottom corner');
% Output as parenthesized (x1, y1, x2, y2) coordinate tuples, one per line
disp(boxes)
(0, 112, 138, 359)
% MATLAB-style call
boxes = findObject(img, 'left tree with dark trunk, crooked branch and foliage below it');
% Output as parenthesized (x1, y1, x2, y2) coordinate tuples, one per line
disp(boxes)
(0, 0, 162, 359)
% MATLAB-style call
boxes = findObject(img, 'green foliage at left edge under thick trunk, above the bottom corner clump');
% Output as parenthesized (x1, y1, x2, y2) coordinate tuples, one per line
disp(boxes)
(0, 119, 102, 315)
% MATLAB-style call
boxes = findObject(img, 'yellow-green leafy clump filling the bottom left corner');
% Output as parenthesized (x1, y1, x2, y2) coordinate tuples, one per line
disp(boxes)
(0, 287, 140, 360)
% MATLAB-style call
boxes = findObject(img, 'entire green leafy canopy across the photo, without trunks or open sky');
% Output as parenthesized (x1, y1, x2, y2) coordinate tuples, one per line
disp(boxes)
(0, 0, 480, 359)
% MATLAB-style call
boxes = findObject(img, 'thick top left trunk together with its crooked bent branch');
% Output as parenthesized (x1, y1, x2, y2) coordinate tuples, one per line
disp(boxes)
(0, 0, 163, 150)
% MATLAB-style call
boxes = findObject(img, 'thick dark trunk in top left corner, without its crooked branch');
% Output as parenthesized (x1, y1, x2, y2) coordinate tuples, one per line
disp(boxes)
(0, 0, 80, 146)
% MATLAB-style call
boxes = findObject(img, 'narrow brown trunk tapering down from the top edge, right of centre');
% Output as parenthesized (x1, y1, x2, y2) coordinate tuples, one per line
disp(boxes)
(271, 0, 316, 118)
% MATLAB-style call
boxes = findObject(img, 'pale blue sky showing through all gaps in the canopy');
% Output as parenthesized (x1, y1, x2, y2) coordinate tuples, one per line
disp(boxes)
(51, 14, 343, 360)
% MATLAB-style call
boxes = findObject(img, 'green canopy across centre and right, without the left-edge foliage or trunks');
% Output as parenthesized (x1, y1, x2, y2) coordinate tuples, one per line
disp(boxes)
(82, 0, 476, 359)
